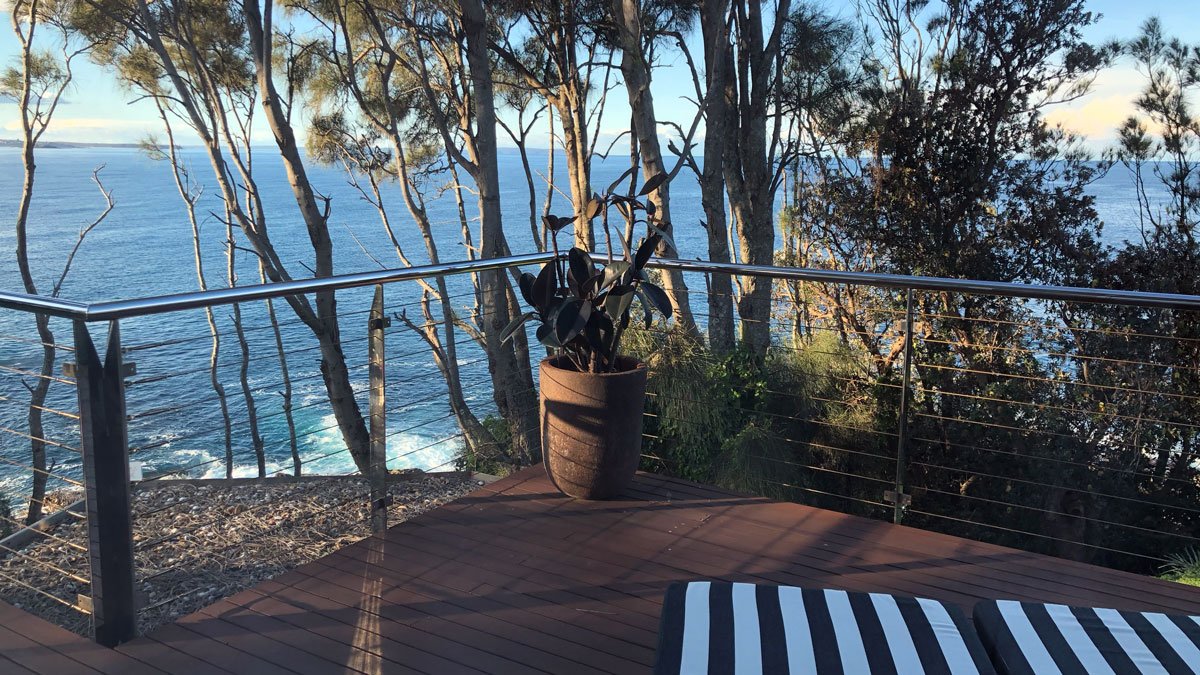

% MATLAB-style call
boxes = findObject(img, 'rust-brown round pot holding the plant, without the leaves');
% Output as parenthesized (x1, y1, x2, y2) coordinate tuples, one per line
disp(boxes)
(539, 357, 646, 500)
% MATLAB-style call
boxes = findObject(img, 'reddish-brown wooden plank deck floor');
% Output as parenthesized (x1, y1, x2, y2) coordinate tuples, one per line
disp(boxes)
(7, 467, 1200, 675)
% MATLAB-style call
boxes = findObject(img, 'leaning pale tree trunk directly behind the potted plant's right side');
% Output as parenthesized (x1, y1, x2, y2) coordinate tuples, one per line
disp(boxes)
(612, 0, 700, 335)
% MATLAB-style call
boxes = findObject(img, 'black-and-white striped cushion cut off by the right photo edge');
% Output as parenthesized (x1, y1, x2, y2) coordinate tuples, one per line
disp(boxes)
(974, 601, 1200, 675)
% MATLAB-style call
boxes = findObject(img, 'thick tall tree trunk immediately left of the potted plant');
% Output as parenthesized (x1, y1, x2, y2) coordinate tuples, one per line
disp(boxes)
(458, 0, 541, 464)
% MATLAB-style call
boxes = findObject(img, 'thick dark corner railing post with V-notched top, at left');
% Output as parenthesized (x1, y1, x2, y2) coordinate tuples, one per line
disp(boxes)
(73, 321, 137, 647)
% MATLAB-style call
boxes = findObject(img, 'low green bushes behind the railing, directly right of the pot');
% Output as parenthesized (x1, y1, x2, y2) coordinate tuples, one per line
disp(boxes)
(629, 329, 894, 510)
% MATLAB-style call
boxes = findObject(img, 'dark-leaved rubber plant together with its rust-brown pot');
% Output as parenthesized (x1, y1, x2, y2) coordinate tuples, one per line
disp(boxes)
(504, 169, 672, 500)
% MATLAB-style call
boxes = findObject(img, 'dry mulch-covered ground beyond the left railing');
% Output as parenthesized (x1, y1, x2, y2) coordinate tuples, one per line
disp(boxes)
(0, 473, 478, 635)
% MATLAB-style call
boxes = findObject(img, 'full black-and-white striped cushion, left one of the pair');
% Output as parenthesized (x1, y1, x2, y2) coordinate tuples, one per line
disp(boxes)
(654, 581, 995, 675)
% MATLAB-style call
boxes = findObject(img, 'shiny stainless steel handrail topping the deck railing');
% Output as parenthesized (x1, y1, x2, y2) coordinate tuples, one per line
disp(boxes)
(0, 253, 1200, 321)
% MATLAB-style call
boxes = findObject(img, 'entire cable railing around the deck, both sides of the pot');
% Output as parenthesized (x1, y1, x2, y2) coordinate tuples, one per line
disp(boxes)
(0, 253, 1200, 644)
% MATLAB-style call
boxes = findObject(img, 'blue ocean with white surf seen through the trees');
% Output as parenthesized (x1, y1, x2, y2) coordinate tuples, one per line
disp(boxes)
(0, 148, 1158, 496)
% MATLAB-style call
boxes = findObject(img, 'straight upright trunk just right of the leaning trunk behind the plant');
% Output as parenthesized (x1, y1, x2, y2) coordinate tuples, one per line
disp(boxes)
(700, 0, 733, 353)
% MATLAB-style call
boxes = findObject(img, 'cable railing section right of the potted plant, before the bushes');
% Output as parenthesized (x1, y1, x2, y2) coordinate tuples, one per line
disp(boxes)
(644, 269, 1200, 573)
